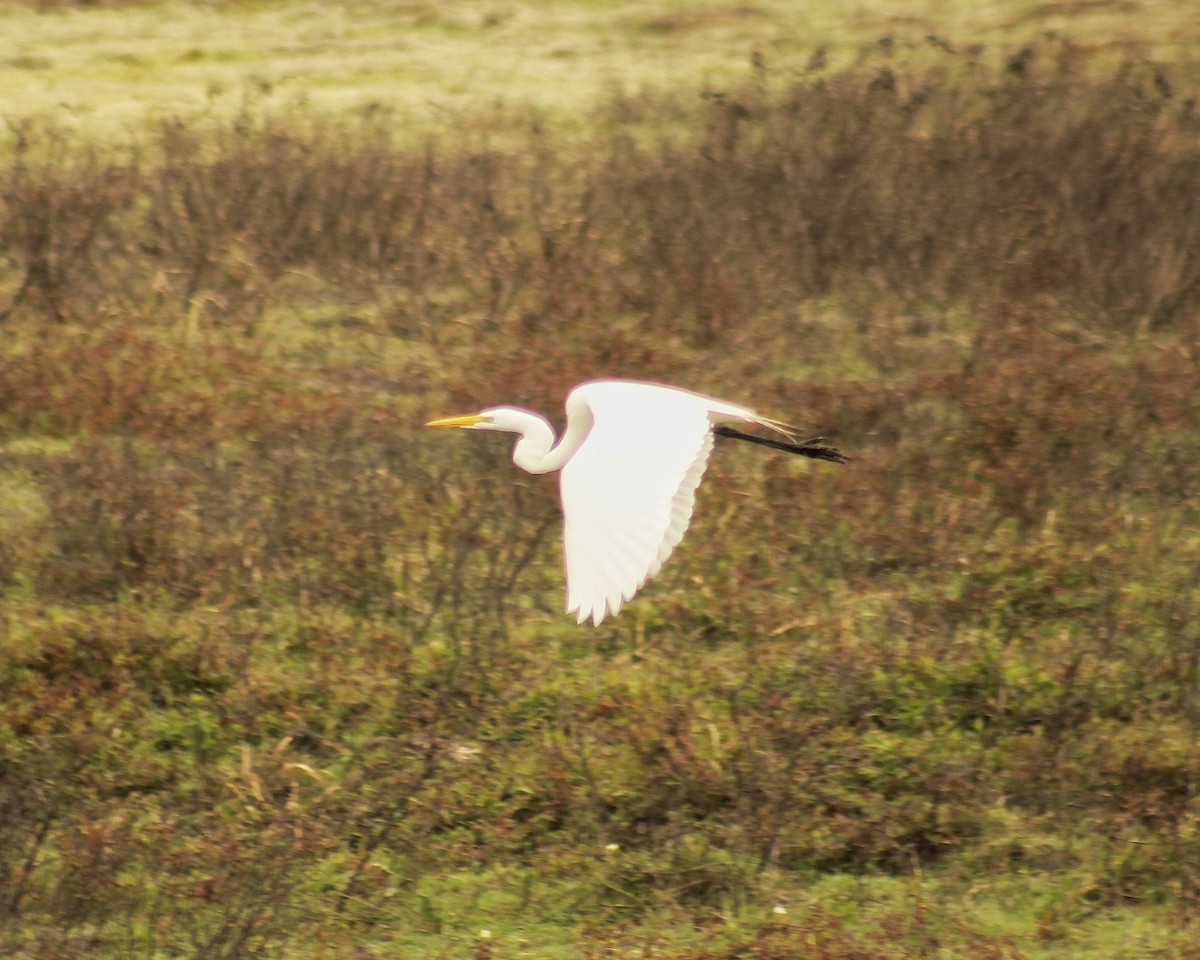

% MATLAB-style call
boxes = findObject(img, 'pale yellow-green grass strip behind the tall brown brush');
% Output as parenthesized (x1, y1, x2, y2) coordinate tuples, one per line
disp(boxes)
(7, 0, 1200, 138)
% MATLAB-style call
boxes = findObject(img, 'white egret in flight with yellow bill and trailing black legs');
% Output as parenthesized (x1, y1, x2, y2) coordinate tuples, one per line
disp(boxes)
(426, 380, 846, 625)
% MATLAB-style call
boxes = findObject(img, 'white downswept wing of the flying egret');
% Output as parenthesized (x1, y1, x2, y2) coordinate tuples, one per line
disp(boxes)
(560, 382, 713, 624)
